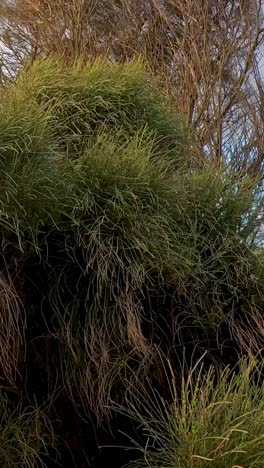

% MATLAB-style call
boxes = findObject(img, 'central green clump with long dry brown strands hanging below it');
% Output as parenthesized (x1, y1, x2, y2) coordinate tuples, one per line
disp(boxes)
(48, 133, 196, 418)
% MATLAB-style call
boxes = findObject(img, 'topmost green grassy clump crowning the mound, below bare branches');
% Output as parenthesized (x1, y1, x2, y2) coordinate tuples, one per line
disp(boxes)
(13, 59, 191, 165)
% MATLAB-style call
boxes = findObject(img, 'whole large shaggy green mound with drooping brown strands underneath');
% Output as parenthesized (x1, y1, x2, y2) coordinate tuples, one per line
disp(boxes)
(0, 60, 264, 464)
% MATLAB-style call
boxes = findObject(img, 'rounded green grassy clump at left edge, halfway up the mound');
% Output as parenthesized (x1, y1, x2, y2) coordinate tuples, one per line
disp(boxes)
(0, 89, 70, 251)
